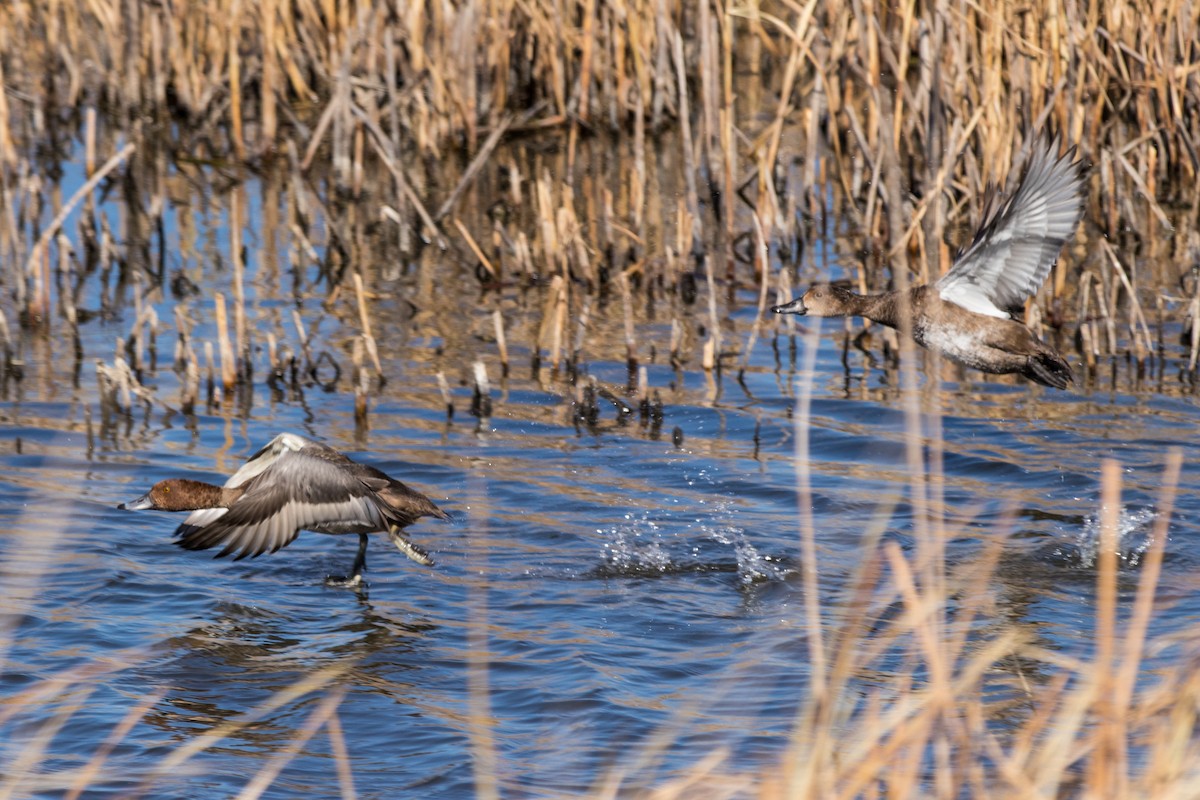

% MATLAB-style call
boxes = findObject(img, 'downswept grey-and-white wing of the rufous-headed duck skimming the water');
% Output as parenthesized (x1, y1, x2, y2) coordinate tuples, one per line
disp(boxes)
(175, 434, 388, 560)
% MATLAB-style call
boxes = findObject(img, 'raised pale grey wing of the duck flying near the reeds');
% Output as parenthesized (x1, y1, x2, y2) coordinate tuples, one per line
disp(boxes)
(934, 137, 1084, 319)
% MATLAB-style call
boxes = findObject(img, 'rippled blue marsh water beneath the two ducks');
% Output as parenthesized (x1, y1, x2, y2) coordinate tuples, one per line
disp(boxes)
(0, 154, 1200, 798)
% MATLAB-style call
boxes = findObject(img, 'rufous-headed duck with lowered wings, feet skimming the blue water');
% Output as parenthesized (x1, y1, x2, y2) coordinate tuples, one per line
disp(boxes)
(118, 433, 450, 588)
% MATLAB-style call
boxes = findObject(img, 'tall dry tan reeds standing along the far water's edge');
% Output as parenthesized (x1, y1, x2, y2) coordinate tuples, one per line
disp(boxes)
(0, 0, 1200, 398)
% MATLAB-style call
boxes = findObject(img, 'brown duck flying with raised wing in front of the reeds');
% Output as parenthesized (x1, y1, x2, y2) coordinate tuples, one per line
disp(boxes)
(772, 136, 1084, 389)
